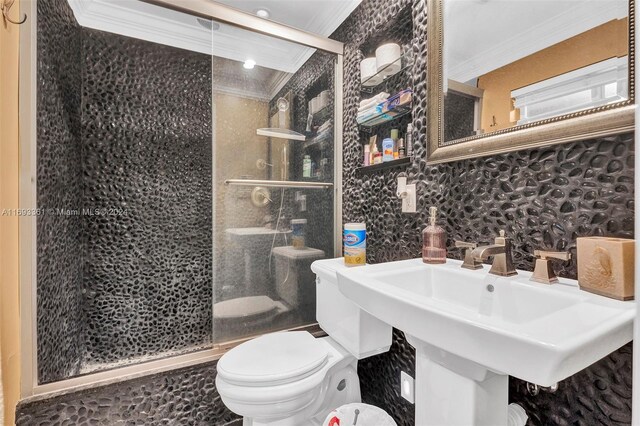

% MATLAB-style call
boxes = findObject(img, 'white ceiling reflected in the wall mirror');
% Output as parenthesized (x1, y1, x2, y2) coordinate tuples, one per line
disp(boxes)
(444, 0, 628, 82)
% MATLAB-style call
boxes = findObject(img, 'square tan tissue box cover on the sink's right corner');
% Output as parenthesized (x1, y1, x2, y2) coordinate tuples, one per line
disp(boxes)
(577, 237, 635, 300)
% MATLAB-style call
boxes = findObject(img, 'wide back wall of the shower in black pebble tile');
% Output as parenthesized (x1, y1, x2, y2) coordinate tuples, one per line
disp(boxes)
(82, 29, 212, 363)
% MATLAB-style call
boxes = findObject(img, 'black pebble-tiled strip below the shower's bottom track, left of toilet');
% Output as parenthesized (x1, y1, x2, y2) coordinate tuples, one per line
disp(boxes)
(16, 364, 242, 426)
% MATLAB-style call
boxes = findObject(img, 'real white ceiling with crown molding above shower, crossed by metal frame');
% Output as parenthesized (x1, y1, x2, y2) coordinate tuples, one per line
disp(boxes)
(68, 0, 361, 73)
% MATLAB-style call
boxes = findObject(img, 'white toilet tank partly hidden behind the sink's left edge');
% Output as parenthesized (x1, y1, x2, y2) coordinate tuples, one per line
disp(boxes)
(311, 258, 392, 359)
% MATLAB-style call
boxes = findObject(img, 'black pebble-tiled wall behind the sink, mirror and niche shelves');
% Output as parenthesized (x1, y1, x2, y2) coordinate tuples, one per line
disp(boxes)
(333, 0, 634, 426)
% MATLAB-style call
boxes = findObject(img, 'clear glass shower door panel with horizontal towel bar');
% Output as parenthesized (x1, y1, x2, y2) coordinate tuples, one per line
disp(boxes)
(212, 26, 335, 343)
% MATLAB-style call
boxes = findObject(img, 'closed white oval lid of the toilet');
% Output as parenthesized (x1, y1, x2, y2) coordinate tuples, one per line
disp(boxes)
(218, 331, 328, 386)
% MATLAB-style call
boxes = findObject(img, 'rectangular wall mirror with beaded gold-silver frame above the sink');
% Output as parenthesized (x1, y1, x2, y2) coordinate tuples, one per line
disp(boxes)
(427, 0, 635, 164)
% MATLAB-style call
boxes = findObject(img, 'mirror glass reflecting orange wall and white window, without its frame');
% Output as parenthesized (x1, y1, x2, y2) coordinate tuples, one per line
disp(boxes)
(443, 0, 629, 141)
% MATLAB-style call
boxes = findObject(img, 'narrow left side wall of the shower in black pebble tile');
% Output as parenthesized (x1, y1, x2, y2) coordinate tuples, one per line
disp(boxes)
(37, 0, 85, 382)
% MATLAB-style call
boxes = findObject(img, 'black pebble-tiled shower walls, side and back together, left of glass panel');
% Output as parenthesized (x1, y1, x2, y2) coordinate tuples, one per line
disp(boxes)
(37, 0, 212, 383)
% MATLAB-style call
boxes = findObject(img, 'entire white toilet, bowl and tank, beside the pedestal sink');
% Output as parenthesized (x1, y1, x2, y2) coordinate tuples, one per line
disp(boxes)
(216, 258, 392, 426)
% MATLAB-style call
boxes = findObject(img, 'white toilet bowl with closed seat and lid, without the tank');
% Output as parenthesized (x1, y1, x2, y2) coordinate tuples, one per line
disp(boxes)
(216, 331, 360, 426)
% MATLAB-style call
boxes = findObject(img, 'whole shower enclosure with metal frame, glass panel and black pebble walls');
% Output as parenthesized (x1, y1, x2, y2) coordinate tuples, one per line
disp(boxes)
(17, 0, 342, 396)
